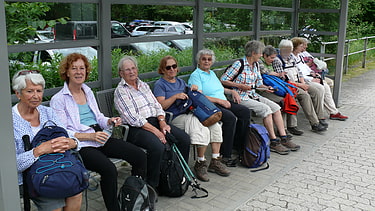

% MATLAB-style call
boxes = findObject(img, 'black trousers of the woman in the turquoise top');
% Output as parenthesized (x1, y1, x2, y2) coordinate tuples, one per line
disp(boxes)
(216, 101, 251, 158)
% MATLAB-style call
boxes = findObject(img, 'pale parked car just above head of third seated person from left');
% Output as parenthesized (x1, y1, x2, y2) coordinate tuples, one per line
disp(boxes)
(118, 41, 171, 54)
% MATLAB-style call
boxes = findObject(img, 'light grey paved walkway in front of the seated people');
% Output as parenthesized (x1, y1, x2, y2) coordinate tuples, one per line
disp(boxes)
(82, 70, 375, 211)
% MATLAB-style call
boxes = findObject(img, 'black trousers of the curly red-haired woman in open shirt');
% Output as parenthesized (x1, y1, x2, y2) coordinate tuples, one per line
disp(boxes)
(79, 138, 147, 211)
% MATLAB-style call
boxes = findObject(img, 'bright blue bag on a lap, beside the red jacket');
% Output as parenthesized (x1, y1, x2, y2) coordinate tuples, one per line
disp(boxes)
(262, 74, 296, 97)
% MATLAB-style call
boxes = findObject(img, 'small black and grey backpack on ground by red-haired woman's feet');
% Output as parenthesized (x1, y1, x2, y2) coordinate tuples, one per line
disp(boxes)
(118, 176, 157, 211)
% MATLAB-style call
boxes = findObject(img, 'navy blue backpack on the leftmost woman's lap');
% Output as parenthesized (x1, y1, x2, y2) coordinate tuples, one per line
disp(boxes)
(26, 121, 89, 198)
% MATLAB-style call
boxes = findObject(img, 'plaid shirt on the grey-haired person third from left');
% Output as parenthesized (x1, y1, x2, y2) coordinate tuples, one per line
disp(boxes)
(114, 79, 165, 127)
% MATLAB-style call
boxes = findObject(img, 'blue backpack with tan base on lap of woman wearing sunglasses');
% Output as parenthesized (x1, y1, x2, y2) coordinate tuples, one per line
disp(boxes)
(187, 90, 223, 127)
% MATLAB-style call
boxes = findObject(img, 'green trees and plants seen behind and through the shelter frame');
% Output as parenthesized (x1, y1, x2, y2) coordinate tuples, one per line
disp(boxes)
(5, 0, 375, 88)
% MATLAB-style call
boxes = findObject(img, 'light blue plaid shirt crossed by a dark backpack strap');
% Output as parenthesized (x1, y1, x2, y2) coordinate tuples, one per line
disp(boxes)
(220, 57, 263, 100)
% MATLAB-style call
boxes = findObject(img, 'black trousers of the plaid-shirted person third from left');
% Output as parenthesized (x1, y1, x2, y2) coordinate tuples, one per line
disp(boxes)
(128, 117, 190, 188)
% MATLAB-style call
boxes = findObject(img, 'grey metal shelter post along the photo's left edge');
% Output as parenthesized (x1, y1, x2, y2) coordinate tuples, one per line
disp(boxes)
(0, 0, 21, 211)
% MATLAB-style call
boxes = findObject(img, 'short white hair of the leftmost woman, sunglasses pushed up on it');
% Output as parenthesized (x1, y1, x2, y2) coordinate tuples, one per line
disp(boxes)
(12, 70, 46, 93)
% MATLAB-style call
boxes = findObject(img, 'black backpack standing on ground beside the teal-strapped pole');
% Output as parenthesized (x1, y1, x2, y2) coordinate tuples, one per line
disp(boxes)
(158, 143, 190, 197)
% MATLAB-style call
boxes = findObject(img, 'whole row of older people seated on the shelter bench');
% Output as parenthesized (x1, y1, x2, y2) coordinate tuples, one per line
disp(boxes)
(12, 38, 347, 211)
